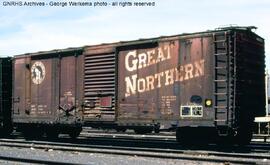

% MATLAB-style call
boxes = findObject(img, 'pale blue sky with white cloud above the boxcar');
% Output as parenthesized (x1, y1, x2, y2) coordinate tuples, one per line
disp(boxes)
(0, 0, 270, 70)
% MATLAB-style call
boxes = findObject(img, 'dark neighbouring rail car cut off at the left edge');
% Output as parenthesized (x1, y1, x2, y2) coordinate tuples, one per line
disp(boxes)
(0, 57, 13, 135)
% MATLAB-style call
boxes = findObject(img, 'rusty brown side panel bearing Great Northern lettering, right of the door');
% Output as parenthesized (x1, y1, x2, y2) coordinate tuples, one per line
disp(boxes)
(117, 36, 213, 128)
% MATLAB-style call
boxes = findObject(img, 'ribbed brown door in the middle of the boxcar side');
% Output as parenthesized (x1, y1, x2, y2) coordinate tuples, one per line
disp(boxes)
(84, 53, 115, 121)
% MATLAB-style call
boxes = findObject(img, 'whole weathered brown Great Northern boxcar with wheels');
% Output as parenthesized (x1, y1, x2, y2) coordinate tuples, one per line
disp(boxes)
(10, 27, 265, 143)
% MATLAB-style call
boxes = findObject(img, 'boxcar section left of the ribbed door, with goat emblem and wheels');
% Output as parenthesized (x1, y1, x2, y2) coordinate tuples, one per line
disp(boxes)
(13, 48, 83, 137)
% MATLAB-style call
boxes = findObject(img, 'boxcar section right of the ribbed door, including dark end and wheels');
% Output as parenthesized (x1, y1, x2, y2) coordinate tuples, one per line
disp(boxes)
(116, 27, 265, 143)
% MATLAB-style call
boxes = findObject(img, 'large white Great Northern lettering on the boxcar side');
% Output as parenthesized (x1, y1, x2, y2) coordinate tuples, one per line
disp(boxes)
(125, 45, 205, 97)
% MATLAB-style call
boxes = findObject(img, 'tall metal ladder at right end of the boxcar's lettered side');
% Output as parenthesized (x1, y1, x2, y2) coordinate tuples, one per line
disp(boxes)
(213, 32, 232, 136)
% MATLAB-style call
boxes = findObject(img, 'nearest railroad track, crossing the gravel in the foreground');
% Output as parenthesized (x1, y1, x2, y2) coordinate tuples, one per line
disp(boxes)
(0, 139, 270, 164)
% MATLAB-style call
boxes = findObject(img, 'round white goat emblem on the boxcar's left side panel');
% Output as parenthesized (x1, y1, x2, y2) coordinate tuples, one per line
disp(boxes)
(31, 61, 45, 84)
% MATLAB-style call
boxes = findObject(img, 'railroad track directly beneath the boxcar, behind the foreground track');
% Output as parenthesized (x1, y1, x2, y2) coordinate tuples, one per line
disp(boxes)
(6, 130, 270, 152)
